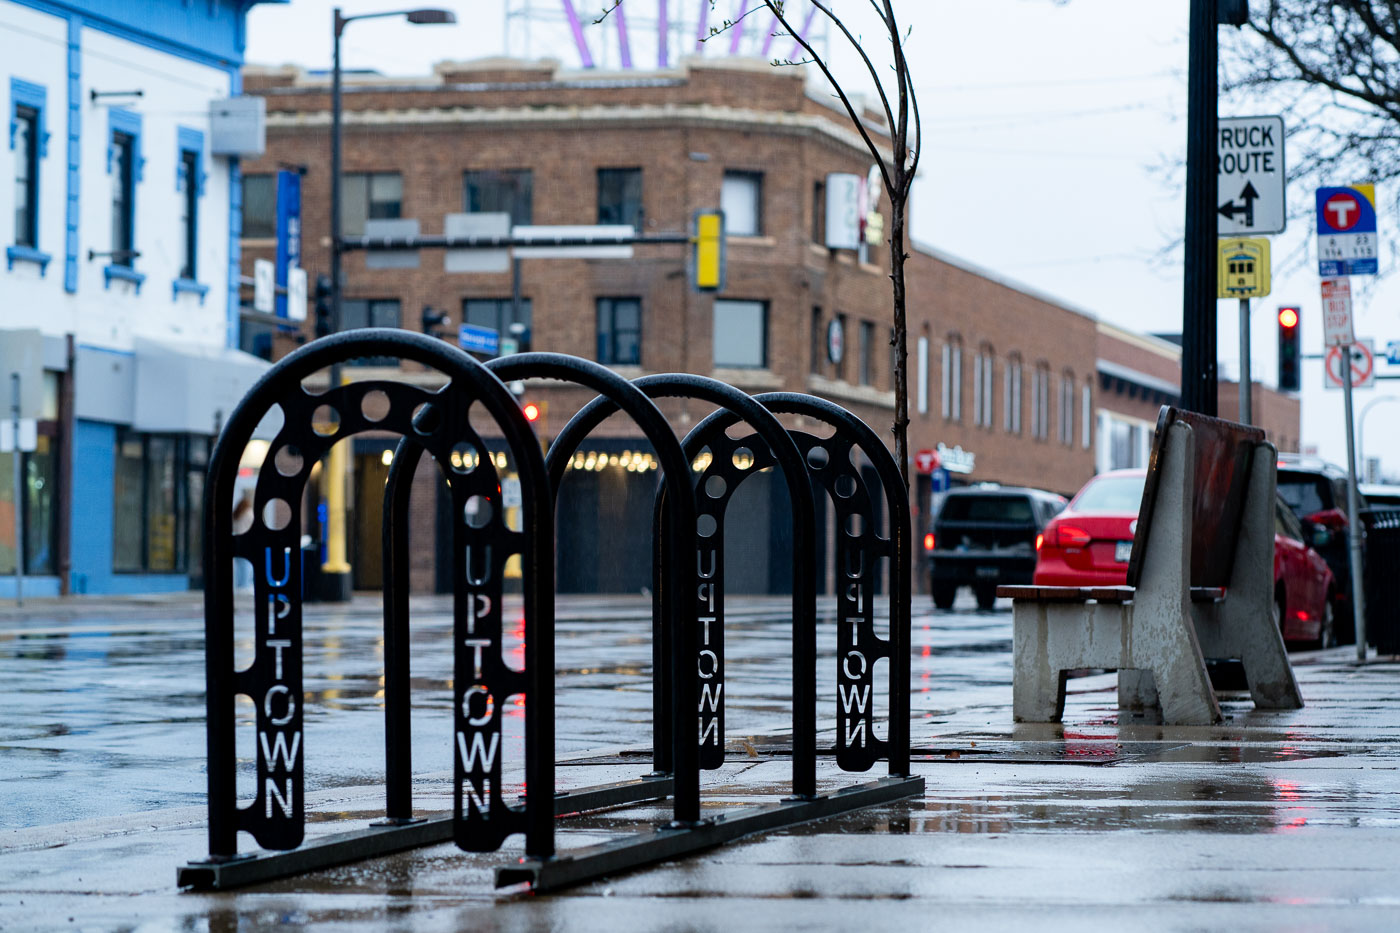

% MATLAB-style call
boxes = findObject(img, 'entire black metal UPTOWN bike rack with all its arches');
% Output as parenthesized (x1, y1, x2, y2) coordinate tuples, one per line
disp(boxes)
(178, 337, 924, 891)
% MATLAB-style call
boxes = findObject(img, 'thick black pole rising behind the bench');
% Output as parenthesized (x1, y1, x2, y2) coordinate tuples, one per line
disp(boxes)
(1182, 0, 1220, 416)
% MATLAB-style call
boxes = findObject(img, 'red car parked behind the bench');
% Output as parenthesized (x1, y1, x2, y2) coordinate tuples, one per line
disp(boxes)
(1035, 469, 1337, 647)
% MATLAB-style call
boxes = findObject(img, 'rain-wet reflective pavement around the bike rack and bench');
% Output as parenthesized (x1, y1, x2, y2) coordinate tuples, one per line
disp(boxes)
(0, 597, 1400, 933)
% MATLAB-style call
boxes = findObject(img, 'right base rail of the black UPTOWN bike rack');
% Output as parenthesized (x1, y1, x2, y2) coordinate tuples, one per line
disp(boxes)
(496, 776, 924, 894)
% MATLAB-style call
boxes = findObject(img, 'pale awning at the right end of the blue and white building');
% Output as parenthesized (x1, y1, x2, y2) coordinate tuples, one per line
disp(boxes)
(132, 338, 269, 434)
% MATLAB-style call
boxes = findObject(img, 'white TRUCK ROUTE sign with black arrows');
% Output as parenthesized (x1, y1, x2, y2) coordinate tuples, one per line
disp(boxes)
(1217, 116, 1288, 237)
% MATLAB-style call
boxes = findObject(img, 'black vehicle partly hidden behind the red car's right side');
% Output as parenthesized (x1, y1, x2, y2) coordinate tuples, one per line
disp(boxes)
(1278, 454, 1369, 644)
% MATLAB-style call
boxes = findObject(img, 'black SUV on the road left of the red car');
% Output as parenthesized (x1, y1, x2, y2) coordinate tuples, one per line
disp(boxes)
(924, 486, 1068, 609)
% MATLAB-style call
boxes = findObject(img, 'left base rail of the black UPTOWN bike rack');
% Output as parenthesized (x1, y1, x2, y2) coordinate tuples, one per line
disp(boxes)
(175, 775, 673, 891)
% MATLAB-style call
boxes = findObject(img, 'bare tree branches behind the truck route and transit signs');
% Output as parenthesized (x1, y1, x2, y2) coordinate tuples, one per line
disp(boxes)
(1221, 0, 1400, 213)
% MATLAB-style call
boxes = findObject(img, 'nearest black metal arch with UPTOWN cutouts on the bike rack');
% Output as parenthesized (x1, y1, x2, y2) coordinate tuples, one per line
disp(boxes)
(178, 329, 554, 887)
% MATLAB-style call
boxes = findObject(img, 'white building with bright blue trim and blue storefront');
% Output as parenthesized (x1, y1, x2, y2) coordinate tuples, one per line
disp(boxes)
(0, 0, 273, 598)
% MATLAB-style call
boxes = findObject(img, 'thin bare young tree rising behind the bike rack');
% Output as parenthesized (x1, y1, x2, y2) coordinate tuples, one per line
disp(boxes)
(603, 0, 923, 488)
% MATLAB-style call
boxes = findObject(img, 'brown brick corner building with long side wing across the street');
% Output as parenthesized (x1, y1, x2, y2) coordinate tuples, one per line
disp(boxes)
(235, 62, 1296, 588)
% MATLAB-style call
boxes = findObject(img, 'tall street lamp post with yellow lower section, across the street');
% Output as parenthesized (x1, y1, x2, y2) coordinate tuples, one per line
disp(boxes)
(322, 7, 456, 601)
